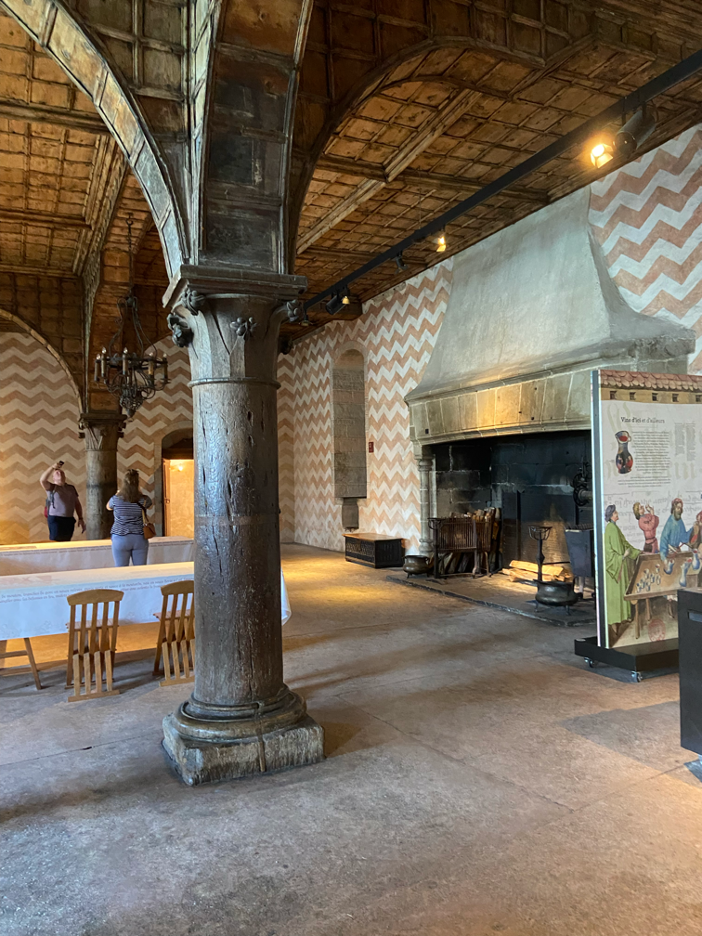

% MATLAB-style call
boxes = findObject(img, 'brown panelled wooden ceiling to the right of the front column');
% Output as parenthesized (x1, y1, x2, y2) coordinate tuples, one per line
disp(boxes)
(296, 0, 702, 299)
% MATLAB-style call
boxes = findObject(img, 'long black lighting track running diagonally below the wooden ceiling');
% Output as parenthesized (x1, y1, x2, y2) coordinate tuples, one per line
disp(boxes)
(305, 49, 702, 309)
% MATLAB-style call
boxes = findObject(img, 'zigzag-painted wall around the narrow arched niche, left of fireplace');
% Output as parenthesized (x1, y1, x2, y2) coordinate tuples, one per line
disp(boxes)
(278, 260, 452, 550)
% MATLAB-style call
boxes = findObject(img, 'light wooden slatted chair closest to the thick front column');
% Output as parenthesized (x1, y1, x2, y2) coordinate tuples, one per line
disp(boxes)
(154, 581, 195, 686)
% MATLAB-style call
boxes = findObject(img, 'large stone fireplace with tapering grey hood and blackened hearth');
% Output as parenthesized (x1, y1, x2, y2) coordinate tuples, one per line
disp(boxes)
(406, 189, 695, 564)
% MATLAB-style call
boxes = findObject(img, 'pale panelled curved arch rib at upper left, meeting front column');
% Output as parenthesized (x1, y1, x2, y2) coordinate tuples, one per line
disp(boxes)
(0, 0, 189, 276)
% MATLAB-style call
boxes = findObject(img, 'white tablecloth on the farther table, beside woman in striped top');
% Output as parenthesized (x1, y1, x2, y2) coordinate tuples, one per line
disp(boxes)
(0, 536, 194, 576)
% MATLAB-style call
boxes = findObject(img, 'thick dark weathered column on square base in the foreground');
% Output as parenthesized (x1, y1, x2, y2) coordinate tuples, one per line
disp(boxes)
(163, 271, 324, 784)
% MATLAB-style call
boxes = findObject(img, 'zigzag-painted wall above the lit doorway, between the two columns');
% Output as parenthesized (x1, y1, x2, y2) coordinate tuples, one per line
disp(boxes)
(117, 338, 193, 498)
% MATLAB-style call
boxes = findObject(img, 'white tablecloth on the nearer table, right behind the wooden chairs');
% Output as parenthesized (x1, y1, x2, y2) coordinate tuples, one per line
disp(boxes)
(0, 562, 290, 640)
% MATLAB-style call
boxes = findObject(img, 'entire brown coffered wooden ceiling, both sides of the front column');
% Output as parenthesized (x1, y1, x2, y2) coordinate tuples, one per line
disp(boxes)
(0, 0, 702, 388)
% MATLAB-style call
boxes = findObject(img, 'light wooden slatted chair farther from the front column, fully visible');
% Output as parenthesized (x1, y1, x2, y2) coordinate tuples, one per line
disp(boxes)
(66, 588, 124, 702)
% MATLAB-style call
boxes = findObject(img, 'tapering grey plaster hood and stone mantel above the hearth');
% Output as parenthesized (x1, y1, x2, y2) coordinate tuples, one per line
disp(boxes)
(405, 188, 695, 445)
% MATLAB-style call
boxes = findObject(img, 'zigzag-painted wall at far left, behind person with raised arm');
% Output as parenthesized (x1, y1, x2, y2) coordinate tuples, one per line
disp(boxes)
(0, 331, 85, 545)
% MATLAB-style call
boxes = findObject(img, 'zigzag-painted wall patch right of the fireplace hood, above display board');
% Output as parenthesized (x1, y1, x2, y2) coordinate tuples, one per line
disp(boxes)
(590, 125, 702, 373)
